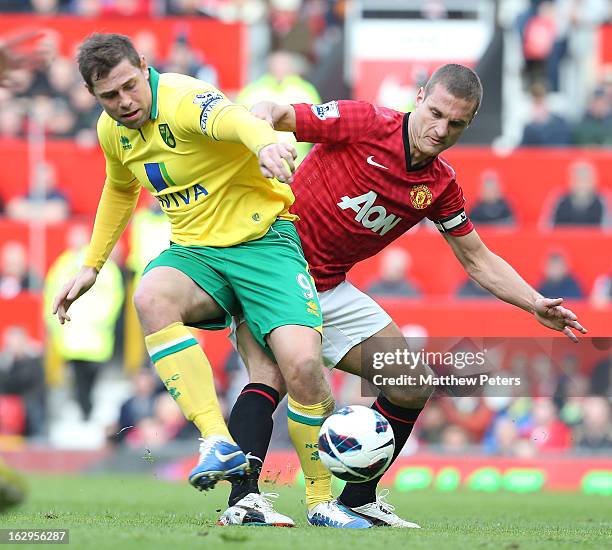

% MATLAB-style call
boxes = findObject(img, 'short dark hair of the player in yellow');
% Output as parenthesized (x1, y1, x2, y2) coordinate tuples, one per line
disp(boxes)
(77, 33, 140, 88)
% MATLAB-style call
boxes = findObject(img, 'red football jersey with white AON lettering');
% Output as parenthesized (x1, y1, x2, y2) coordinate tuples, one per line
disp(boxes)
(291, 101, 474, 290)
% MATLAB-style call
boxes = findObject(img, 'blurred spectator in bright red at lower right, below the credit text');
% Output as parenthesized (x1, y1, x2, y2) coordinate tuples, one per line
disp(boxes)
(529, 397, 572, 452)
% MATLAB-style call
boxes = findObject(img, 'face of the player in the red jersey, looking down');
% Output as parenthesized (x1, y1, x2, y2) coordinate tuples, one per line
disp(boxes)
(410, 84, 476, 156)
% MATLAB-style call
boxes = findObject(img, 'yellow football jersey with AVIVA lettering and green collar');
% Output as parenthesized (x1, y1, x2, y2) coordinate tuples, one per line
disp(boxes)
(92, 68, 296, 256)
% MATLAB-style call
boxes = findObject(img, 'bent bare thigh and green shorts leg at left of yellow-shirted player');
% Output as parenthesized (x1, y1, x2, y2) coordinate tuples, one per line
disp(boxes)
(134, 245, 239, 330)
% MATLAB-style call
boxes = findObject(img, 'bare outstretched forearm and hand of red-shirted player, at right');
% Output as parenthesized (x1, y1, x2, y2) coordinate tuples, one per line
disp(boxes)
(444, 230, 587, 342)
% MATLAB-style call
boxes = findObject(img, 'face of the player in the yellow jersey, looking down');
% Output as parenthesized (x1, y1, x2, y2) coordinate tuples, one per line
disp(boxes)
(89, 58, 152, 130)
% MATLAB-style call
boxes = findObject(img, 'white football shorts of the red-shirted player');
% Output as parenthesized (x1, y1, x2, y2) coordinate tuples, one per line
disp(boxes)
(229, 281, 391, 369)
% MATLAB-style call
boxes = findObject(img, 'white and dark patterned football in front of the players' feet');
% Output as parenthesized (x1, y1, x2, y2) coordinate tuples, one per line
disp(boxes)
(319, 405, 395, 482)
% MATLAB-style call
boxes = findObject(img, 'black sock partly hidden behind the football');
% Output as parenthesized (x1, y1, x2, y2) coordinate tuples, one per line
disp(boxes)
(338, 394, 423, 508)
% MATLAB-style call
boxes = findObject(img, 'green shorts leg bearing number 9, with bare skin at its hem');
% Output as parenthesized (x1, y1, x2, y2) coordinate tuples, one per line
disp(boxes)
(226, 220, 322, 352)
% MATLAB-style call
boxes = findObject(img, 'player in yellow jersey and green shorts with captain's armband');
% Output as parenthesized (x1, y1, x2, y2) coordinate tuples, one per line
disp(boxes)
(53, 34, 334, 524)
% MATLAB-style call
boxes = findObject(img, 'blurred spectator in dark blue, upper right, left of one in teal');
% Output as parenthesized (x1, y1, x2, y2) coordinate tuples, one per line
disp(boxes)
(521, 83, 572, 147)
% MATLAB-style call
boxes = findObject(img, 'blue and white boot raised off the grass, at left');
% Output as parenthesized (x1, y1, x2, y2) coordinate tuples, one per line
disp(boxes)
(189, 435, 249, 491)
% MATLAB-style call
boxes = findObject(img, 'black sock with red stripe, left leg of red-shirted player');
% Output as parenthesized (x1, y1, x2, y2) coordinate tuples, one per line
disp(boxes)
(228, 384, 279, 506)
